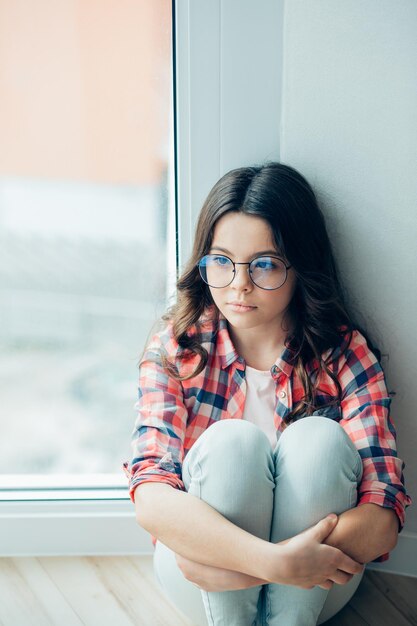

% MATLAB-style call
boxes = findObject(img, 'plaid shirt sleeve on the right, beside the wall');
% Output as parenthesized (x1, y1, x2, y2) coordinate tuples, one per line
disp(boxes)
(339, 330, 412, 561)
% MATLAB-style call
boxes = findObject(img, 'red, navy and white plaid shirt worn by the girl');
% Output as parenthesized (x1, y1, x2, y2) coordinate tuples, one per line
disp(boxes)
(122, 313, 412, 562)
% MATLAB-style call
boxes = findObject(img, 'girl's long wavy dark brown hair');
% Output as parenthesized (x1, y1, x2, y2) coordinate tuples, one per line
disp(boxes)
(154, 162, 381, 423)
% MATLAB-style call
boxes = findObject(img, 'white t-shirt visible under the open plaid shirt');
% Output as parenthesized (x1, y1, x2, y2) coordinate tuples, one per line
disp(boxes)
(243, 365, 281, 449)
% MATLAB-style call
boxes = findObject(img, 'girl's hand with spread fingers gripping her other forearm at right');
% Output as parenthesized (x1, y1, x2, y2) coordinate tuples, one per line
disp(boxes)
(270, 516, 364, 589)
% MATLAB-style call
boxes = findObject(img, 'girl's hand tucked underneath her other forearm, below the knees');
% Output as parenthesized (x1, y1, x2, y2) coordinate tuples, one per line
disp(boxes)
(175, 554, 268, 591)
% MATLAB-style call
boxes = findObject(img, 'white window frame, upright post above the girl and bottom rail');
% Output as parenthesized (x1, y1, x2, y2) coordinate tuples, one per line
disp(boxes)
(0, 0, 283, 556)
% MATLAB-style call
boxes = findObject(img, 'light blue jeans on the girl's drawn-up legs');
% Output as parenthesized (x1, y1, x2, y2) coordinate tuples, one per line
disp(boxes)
(153, 415, 363, 626)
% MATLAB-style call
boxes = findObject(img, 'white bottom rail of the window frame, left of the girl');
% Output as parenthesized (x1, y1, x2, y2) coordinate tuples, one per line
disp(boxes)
(0, 478, 153, 557)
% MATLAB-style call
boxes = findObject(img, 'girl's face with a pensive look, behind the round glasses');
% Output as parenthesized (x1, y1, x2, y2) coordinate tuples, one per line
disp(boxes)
(209, 212, 296, 333)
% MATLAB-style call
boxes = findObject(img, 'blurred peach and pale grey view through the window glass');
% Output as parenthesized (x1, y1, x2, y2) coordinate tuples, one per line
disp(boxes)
(0, 0, 175, 475)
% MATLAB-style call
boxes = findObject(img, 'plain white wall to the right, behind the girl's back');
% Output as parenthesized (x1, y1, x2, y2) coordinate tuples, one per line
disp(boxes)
(281, 0, 417, 532)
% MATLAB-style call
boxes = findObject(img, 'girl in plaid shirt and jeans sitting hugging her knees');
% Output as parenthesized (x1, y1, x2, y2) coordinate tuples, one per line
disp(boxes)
(123, 163, 411, 626)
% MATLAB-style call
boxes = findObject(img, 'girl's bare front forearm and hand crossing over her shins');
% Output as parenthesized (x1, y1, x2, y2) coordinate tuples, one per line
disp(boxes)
(135, 482, 363, 588)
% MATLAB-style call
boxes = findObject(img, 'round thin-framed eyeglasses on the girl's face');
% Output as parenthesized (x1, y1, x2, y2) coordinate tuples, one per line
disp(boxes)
(197, 254, 291, 290)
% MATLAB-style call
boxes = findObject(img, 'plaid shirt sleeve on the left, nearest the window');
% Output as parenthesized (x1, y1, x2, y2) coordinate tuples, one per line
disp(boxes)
(123, 335, 188, 502)
